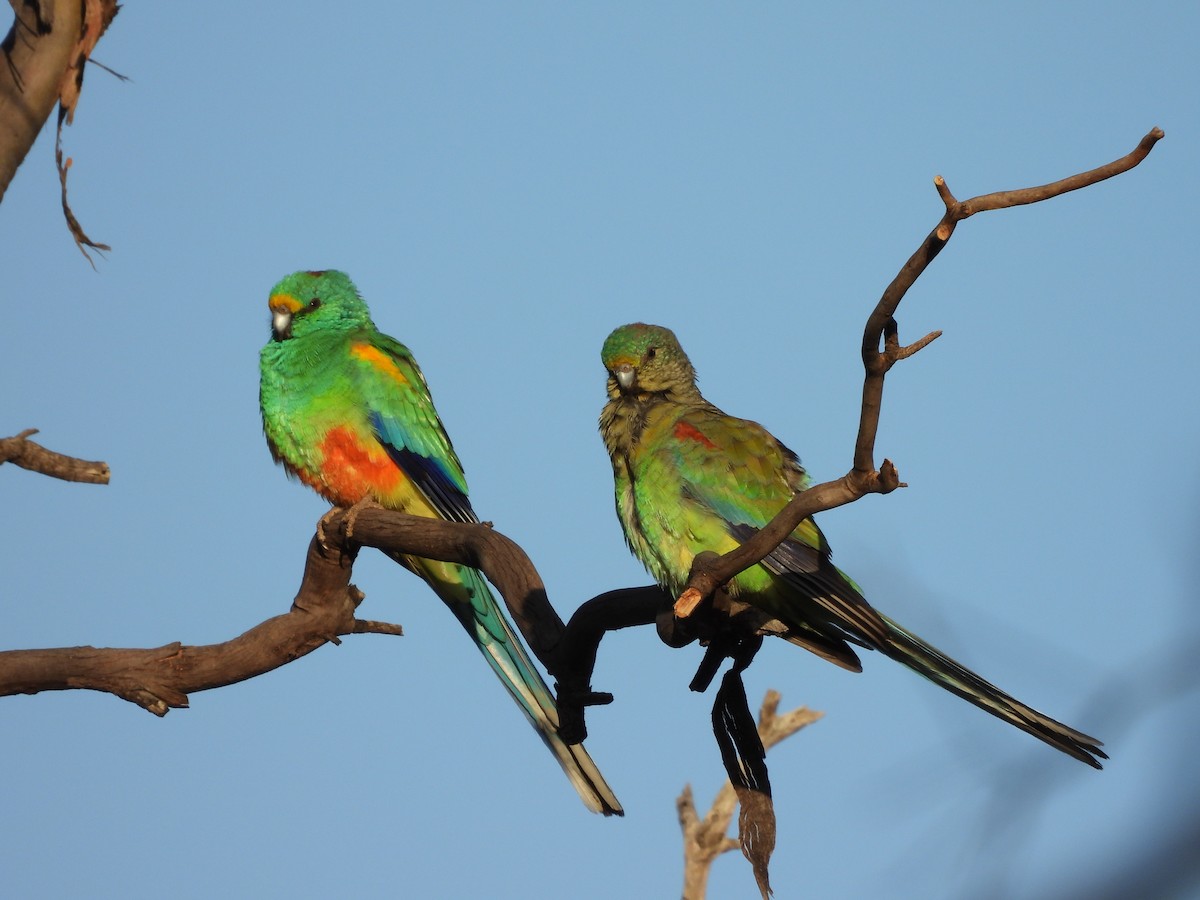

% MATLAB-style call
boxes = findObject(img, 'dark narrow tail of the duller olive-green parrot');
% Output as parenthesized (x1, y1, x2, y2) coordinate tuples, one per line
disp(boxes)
(878, 614, 1109, 769)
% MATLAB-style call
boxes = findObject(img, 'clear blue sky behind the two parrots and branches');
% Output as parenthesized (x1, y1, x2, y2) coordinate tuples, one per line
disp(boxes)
(0, 4, 1200, 899)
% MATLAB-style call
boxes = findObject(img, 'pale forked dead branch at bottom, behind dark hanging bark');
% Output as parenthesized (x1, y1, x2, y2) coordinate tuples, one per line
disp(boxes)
(676, 690, 823, 900)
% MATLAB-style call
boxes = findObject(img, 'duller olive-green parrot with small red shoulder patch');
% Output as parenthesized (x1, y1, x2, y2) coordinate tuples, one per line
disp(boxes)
(600, 324, 1108, 768)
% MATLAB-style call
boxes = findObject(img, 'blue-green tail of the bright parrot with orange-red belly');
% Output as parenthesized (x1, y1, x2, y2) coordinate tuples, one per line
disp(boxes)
(396, 557, 625, 816)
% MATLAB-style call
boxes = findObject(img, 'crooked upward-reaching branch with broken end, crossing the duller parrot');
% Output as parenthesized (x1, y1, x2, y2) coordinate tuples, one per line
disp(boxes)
(679, 128, 1163, 619)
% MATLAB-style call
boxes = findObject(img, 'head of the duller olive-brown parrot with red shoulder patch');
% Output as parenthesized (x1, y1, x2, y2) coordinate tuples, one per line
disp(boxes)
(600, 322, 696, 398)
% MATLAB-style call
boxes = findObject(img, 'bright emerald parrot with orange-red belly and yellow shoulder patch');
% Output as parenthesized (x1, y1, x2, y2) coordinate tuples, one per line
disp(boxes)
(259, 271, 624, 816)
